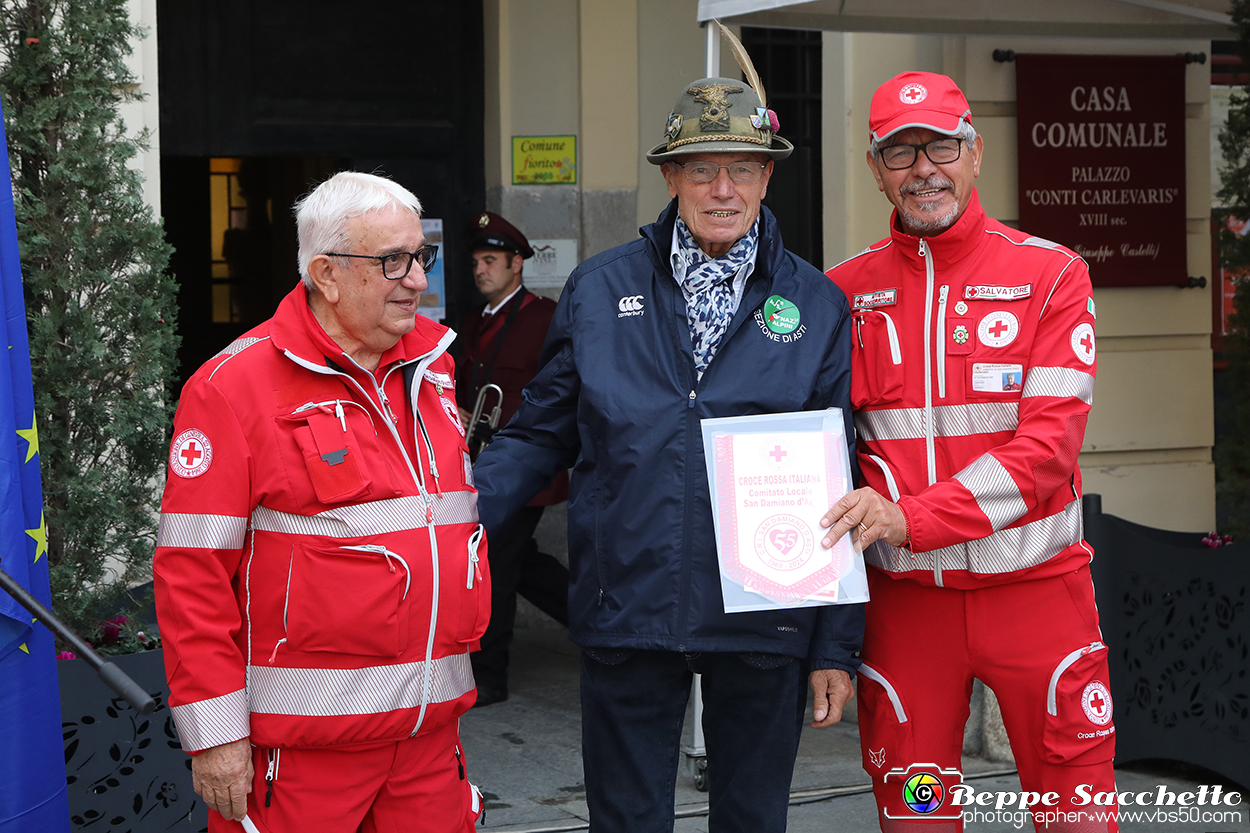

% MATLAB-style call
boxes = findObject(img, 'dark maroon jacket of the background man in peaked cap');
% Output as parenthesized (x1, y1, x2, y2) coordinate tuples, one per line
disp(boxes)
(456, 288, 569, 507)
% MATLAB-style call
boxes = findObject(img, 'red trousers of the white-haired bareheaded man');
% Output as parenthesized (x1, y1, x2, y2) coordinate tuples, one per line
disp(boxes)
(209, 720, 481, 833)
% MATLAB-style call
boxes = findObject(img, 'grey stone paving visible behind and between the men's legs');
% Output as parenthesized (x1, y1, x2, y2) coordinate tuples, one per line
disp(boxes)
(460, 628, 1250, 833)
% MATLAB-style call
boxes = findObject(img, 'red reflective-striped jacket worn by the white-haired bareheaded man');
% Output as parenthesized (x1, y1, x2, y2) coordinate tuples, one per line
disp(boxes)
(154, 286, 490, 752)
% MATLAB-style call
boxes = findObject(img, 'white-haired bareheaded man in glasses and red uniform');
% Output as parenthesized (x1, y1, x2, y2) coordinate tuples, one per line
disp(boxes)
(154, 173, 490, 833)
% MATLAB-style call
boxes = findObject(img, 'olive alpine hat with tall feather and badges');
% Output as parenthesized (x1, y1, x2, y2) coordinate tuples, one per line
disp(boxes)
(646, 20, 794, 165)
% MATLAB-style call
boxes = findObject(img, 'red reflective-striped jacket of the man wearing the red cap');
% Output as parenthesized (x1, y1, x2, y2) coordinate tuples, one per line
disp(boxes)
(829, 191, 1096, 589)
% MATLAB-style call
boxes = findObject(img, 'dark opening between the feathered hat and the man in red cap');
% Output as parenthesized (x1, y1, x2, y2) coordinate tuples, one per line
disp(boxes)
(743, 26, 825, 269)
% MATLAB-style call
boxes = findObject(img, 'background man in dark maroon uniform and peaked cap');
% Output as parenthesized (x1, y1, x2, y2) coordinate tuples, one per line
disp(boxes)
(456, 211, 569, 705)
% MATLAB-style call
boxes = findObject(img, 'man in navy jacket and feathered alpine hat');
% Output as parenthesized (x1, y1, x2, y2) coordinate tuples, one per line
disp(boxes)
(475, 72, 864, 833)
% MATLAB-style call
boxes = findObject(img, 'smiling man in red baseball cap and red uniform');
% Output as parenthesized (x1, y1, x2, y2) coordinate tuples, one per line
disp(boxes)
(825, 73, 1118, 832)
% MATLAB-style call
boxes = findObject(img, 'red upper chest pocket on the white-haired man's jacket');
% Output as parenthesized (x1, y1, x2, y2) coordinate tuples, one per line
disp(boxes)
(280, 400, 394, 504)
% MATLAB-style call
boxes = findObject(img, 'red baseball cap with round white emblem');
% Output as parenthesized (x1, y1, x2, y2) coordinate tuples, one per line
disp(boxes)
(868, 73, 973, 141)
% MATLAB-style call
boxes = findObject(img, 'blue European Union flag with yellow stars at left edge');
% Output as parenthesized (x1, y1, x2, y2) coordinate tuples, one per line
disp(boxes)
(0, 100, 70, 833)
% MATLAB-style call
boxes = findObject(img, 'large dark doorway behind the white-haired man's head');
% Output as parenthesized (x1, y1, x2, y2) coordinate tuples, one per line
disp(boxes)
(156, 0, 486, 390)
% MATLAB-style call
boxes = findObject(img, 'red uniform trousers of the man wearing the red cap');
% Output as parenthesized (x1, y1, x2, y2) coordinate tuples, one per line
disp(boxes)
(858, 567, 1119, 833)
